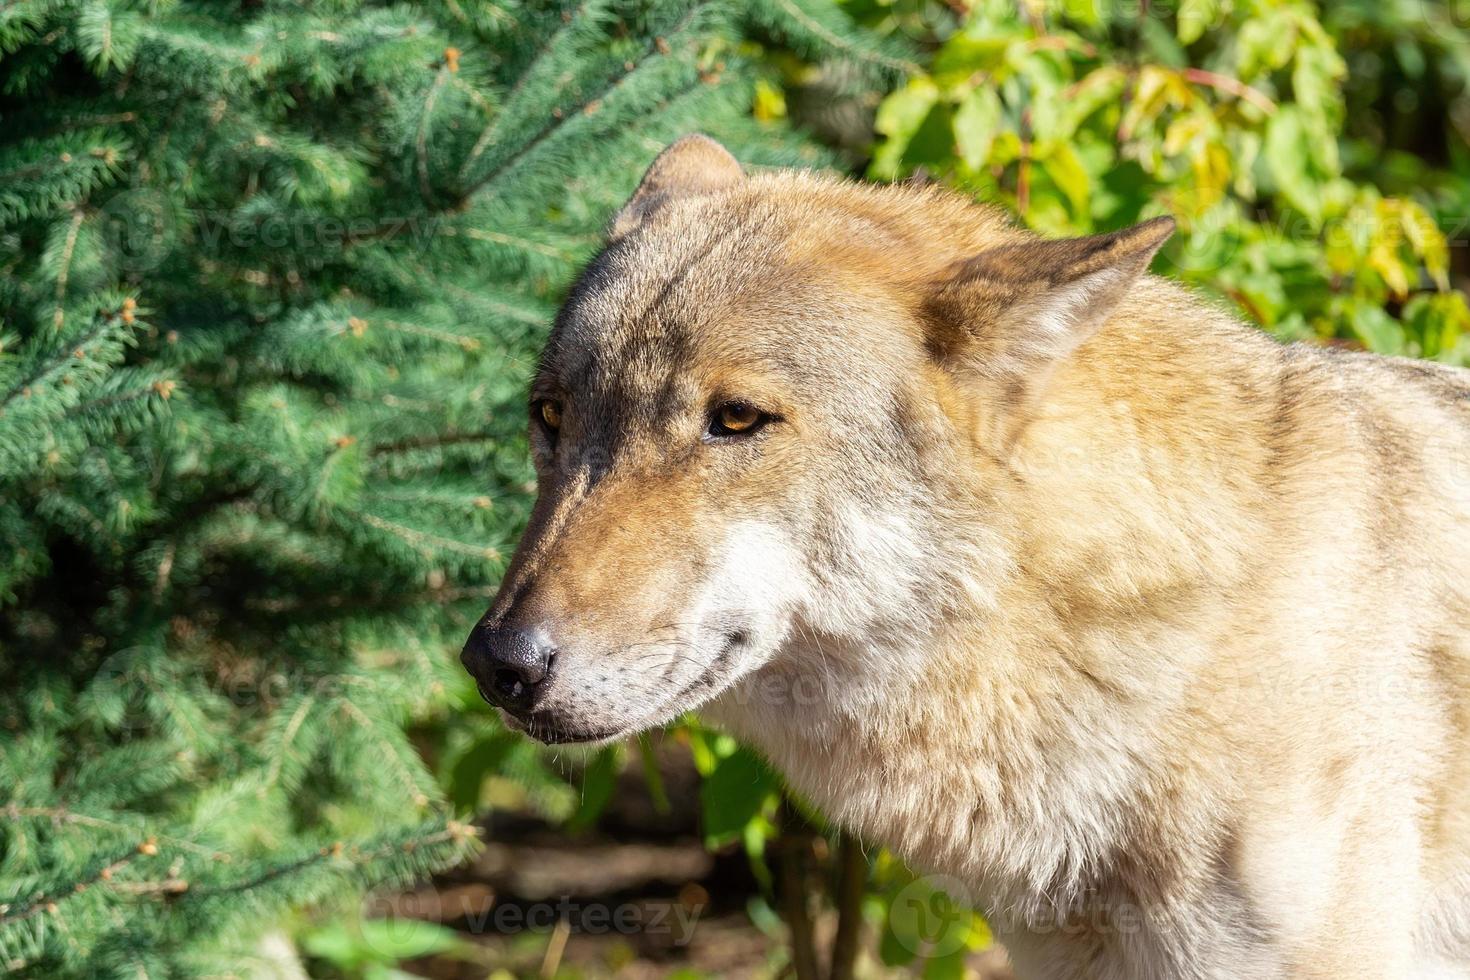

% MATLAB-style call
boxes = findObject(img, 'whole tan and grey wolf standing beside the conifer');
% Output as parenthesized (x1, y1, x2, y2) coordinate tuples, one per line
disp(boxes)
(462, 135, 1470, 980)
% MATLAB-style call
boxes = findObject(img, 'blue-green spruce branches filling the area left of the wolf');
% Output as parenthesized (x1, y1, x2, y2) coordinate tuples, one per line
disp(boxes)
(0, 0, 898, 977)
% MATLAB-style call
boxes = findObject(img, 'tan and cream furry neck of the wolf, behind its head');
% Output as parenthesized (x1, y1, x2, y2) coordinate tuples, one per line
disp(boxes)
(711, 295, 1270, 909)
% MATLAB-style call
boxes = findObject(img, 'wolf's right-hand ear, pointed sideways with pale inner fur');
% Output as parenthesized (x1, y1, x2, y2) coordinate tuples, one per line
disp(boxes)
(925, 217, 1175, 444)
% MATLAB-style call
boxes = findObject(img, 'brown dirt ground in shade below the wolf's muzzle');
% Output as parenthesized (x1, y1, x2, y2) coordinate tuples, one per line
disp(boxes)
(382, 752, 1011, 980)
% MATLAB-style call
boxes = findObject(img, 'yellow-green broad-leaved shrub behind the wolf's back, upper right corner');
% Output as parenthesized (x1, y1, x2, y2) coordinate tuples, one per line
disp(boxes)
(866, 0, 1470, 363)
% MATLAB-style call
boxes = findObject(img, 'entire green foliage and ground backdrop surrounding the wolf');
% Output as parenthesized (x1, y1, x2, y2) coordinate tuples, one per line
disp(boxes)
(0, 0, 1470, 980)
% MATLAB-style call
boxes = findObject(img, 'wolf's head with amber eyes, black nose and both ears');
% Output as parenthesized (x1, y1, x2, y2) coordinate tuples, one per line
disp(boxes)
(462, 137, 1173, 742)
